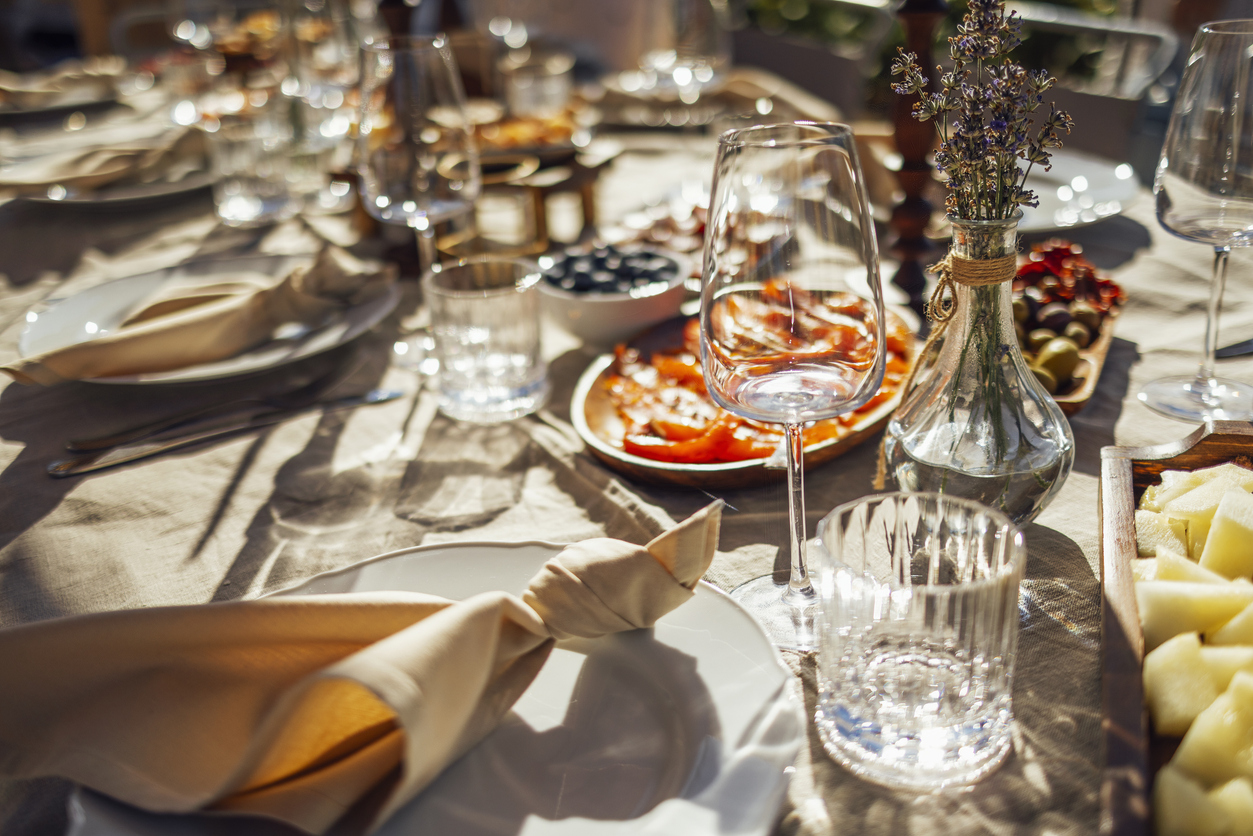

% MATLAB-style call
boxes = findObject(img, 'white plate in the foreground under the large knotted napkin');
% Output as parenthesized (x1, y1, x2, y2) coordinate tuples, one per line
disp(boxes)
(68, 543, 806, 836)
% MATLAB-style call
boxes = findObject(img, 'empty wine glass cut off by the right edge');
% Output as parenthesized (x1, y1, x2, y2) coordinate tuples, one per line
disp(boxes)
(1139, 20, 1253, 421)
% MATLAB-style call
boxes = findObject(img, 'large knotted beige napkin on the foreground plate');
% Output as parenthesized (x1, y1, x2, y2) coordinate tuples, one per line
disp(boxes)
(0, 501, 722, 833)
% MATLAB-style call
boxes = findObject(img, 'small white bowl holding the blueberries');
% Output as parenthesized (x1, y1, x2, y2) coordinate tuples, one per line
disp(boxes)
(539, 247, 690, 346)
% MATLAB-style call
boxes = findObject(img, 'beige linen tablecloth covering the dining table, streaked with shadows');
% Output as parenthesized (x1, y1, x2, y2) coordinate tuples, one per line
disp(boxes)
(0, 94, 1253, 836)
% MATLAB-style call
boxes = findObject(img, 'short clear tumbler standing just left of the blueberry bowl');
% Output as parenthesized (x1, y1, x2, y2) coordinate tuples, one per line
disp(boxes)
(422, 256, 549, 424)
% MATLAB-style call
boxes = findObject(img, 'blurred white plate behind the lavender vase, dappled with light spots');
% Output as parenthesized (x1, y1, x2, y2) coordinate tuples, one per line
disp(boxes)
(1019, 149, 1140, 232)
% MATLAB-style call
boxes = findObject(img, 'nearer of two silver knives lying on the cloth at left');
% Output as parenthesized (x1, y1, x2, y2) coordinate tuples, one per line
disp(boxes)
(48, 389, 405, 478)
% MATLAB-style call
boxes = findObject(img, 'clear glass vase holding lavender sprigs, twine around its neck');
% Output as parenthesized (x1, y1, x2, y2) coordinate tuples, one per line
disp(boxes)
(885, 212, 1075, 524)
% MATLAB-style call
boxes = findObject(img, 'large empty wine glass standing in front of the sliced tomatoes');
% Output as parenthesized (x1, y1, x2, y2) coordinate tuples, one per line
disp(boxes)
(700, 122, 885, 651)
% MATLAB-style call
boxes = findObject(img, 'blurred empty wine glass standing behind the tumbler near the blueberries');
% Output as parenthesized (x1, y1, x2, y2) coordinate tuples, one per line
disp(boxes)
(357, 35, 480, 266)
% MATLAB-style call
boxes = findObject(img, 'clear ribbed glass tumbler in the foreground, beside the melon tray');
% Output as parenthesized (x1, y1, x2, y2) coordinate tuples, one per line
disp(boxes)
(814, 493, 1026, 790)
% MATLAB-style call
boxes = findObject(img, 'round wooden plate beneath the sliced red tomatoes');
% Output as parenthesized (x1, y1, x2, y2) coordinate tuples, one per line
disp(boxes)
(570, 317, 901, 489)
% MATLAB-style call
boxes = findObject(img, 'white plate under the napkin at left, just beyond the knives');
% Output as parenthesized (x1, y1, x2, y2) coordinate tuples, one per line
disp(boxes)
(18, 256, 400, 384)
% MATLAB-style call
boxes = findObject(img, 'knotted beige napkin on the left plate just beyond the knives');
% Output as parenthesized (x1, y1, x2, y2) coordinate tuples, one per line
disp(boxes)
(0, 246, 396, 386)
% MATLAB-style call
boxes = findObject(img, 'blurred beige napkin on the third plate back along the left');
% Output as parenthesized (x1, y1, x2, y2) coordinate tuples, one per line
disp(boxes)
(0, 128, 204, 196)
